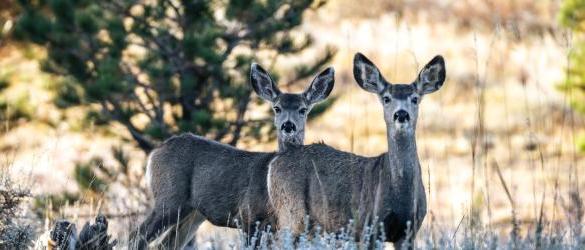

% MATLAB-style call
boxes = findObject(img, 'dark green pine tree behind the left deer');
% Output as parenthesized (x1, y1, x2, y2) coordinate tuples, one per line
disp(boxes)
(13, 0, 335, 152)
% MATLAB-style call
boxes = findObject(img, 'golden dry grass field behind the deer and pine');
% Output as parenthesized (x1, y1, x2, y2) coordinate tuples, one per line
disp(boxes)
(0, 0, 585, 249)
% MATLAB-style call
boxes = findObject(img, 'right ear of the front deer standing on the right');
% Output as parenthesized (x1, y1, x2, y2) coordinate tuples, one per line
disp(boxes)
(414, 55, 446, 95)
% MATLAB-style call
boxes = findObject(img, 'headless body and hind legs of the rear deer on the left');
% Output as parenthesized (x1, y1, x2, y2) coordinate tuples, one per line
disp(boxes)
(135, 136, 275, 249)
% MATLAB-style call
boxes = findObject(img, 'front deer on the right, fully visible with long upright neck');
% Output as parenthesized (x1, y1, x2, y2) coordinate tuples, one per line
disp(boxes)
(268, 53, 445, 249)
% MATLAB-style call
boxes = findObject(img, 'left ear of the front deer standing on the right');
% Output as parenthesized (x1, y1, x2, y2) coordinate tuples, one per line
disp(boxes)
(353, 53, 386, 94)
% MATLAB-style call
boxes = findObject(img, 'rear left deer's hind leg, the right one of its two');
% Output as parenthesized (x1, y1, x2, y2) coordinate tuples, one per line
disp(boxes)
(151, 210, 205, 249)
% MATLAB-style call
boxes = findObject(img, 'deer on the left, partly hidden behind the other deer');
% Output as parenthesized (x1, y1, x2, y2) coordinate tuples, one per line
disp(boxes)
(130, 64, 334, 249)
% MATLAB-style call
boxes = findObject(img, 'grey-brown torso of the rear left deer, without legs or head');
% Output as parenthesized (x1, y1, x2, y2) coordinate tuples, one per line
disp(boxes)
(150, 134, 275, 227)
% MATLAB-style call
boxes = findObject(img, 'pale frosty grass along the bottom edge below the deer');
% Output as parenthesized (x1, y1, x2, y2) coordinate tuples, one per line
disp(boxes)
(216, 217, 585, 250)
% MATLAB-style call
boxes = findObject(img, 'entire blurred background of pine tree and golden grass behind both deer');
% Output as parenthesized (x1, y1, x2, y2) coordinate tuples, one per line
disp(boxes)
(0, 0, 585, 246)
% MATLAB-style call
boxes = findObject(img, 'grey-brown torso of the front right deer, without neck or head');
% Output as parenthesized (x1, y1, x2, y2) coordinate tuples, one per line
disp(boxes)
(269, 140, 426, 241)
